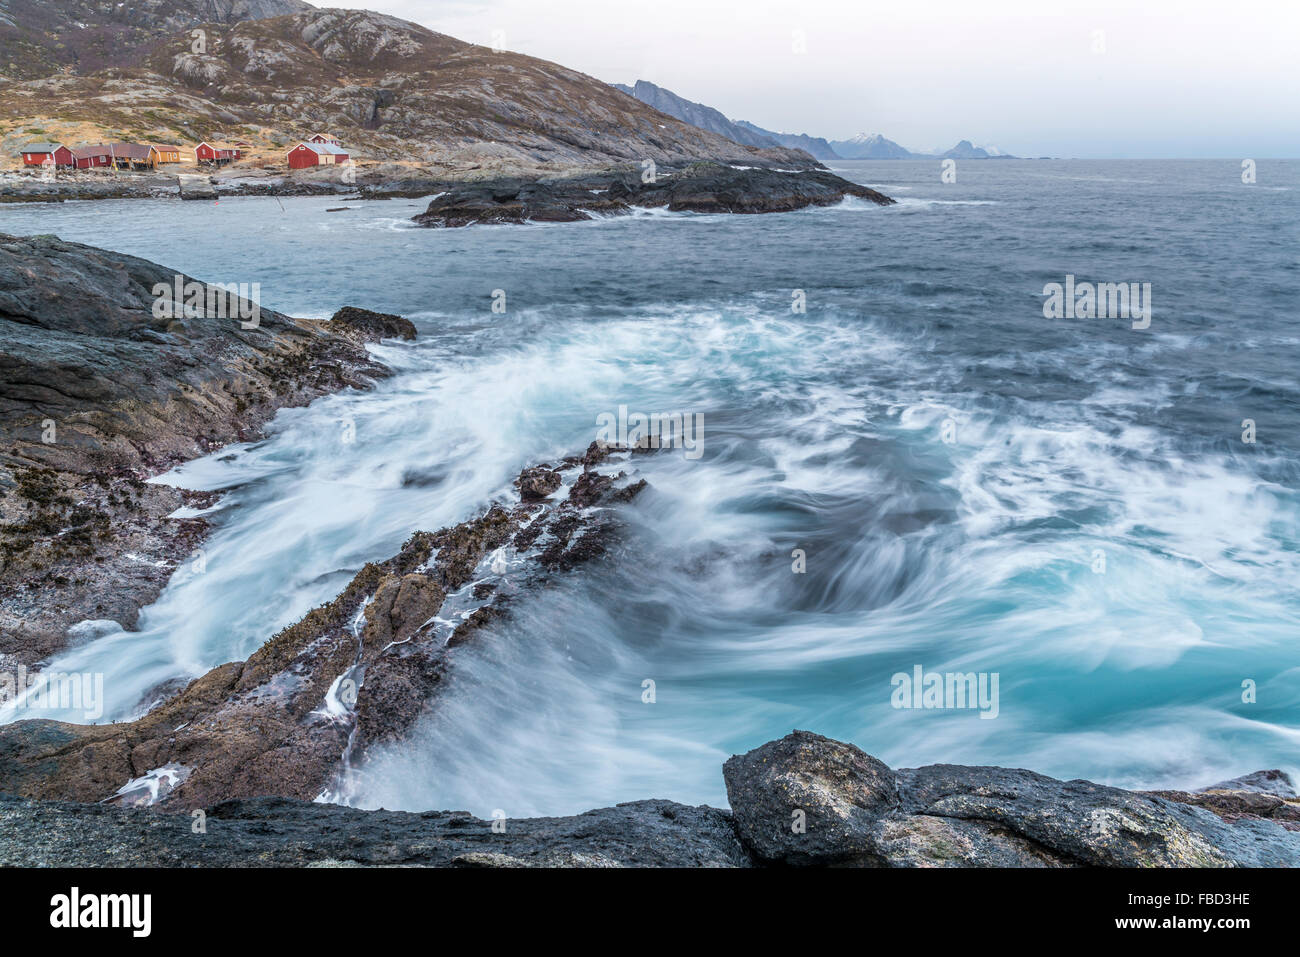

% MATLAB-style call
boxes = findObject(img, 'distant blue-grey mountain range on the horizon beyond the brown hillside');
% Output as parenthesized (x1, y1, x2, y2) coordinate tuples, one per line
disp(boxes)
(612, 79, 1015, 161)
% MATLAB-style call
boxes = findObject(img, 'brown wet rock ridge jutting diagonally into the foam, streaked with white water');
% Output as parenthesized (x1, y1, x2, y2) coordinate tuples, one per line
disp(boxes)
(0, 444, 645, 810)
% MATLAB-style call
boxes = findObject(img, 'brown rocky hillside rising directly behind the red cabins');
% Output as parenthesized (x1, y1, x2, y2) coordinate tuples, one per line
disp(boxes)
(0, 6, 815, 176)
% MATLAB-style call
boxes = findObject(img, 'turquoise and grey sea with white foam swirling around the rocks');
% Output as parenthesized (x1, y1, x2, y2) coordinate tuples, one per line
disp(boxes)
(0, 160, 1300, 817)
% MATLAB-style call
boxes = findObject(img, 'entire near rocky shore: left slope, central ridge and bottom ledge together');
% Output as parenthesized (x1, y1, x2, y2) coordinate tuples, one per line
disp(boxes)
(0, 230, 1300, 867)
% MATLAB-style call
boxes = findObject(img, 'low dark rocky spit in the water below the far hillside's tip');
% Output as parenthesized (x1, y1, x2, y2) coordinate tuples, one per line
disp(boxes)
(412, 163, 894, 226)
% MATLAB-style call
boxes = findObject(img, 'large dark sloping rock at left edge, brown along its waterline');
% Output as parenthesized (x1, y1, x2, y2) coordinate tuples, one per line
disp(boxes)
(0, 235, 411, 670)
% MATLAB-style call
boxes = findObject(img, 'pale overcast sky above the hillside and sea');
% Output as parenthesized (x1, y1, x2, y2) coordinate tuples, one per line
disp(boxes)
(371, 0, 1300, 157)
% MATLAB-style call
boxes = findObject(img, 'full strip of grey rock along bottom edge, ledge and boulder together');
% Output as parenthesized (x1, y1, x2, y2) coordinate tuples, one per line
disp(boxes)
(0, 731, 1300, 867)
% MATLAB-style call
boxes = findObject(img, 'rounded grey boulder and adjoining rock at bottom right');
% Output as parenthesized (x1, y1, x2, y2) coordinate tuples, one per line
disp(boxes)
(723, 731, 1300, 867)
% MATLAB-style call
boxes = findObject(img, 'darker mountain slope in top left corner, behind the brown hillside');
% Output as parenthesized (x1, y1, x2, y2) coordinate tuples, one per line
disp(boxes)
(0, 0, 313, 79)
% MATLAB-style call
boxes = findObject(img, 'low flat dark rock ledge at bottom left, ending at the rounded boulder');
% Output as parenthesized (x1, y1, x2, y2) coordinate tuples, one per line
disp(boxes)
(0, 796, 750, 867)
